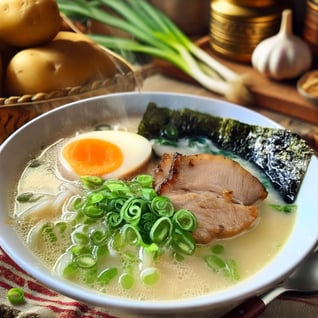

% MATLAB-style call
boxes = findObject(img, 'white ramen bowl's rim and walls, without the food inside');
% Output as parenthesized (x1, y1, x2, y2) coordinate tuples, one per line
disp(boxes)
(0, 92, 318, 316)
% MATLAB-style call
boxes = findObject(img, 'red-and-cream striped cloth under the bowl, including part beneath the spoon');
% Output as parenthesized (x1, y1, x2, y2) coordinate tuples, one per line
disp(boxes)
(0, 248, 318, 318)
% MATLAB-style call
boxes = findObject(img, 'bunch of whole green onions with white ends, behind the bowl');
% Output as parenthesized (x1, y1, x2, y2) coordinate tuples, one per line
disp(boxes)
(58, 0, 250, 102)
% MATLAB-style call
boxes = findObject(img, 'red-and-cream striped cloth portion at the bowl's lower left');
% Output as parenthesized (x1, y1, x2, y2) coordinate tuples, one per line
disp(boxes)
(0, 248, 112, 318)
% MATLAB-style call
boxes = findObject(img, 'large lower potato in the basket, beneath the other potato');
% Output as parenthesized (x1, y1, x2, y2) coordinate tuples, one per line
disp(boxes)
(5, 32, 117, 96)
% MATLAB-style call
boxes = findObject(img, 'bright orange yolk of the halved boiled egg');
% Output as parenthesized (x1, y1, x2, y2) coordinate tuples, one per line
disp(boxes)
(63, 138, 123, 176)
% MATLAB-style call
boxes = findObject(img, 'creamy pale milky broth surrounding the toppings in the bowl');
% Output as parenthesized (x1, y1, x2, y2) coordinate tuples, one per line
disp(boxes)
(12, 120, 296, 300)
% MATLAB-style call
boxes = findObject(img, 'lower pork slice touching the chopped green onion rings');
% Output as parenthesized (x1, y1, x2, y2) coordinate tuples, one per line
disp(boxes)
(168, 191, 258, 244)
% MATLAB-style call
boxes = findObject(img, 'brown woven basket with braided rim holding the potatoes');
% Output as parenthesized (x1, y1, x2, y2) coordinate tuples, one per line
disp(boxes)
(0, 14, 157, 144)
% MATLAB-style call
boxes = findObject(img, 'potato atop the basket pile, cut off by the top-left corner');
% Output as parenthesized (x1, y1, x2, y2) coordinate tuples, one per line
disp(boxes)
(0, 0, 61, 47)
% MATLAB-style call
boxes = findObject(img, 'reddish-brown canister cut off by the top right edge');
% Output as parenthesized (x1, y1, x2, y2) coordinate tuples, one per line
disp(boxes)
(303, 0, 318, 58)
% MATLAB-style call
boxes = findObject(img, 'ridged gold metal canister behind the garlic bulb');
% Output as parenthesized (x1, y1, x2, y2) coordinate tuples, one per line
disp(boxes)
(210, 0, 286, 63)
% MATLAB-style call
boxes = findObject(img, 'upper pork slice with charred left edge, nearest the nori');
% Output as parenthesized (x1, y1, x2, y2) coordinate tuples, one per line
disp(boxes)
(154, 153, 267, 205)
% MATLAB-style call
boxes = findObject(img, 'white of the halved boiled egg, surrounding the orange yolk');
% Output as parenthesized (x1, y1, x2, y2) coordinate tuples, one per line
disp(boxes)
(58, 130, 152, 180)
